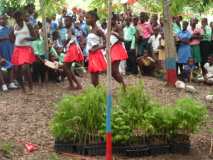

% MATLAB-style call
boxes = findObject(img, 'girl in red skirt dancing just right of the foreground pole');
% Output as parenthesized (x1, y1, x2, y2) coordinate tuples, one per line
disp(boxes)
(110, 16, 128, 90)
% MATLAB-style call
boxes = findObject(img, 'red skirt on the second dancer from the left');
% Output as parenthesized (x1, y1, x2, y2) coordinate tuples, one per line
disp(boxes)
(64, 43, 84, 63)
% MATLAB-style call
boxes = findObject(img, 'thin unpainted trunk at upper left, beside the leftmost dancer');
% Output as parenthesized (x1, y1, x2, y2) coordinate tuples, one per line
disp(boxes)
(39, 0, 49, 54)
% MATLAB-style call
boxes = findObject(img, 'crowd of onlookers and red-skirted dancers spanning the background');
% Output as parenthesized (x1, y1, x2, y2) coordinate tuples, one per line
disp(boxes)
(0, 4, 213, 92)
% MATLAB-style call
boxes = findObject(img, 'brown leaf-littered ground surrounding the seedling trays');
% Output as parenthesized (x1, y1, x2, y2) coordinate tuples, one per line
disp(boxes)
(0, 75, 213, 160)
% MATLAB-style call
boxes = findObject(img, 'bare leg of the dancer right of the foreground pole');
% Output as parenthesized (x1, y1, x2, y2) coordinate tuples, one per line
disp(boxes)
(112, 61, 126, 91)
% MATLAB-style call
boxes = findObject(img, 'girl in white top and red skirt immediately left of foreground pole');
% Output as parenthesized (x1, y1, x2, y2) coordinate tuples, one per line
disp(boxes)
(86, 11, 107, 86)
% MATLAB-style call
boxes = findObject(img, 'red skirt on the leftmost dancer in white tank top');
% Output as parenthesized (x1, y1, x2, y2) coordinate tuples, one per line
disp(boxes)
(11, 46, 36, 66)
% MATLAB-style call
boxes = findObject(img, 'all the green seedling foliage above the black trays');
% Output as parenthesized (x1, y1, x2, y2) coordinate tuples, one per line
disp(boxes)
(51, 81, 207, 144)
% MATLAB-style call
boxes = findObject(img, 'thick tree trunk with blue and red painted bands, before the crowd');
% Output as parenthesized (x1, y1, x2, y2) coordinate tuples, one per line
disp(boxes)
(163, 0, 177, 86)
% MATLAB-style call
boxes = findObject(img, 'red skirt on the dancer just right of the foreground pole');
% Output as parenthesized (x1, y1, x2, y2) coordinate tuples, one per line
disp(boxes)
(110, 43, 128, 63)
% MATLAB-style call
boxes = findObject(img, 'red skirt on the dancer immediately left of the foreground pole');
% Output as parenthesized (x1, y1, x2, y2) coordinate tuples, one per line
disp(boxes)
(88, 50, 107, 73)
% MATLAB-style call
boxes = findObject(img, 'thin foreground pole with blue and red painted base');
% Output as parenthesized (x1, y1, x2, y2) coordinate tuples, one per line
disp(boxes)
(106, 0, 112, 160)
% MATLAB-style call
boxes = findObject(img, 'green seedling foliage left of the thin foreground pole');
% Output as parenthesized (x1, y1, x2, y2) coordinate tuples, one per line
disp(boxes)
(51, 87, 106, 143)
